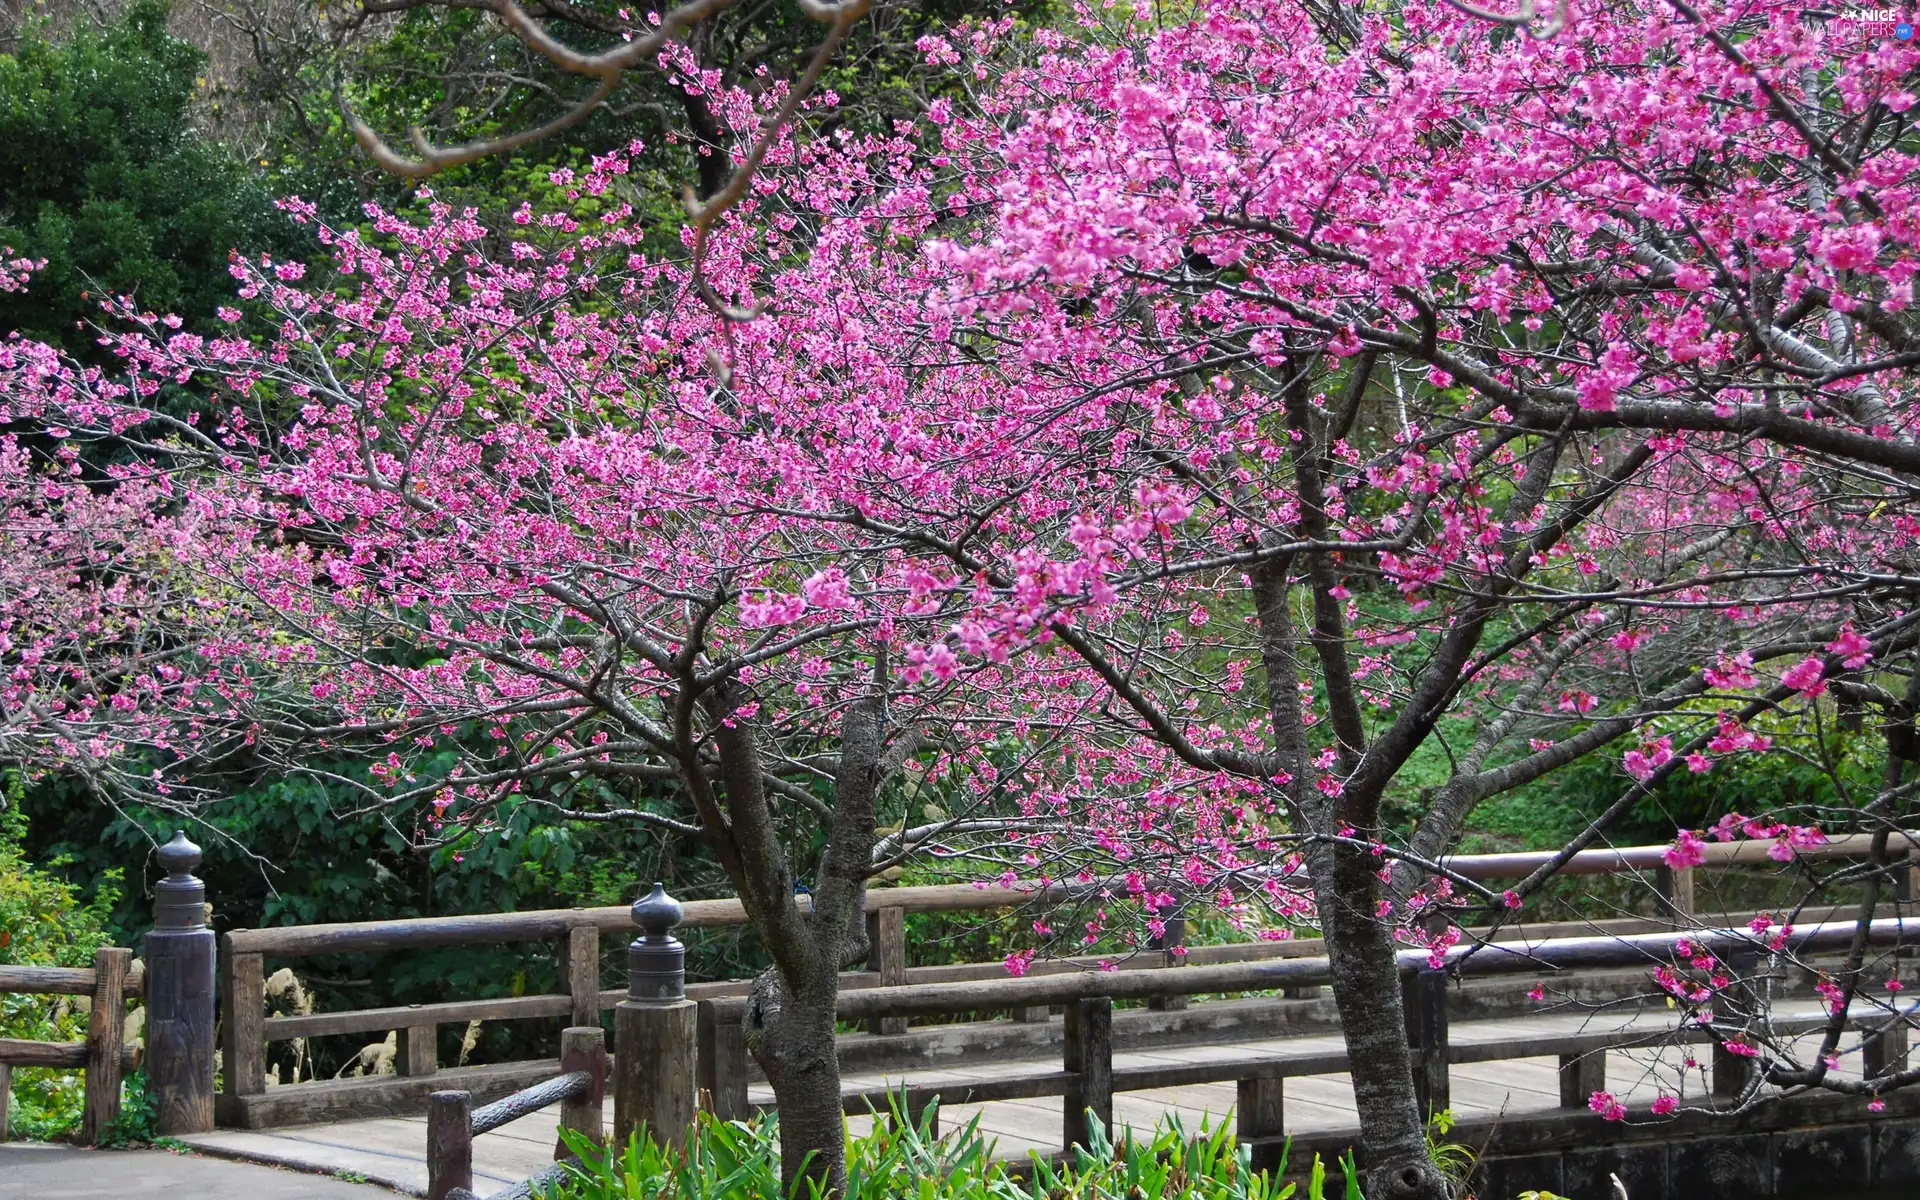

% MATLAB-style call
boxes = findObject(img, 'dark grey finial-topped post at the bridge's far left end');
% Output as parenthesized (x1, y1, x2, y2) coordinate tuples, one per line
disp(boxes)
(144, 829, 213, 1135)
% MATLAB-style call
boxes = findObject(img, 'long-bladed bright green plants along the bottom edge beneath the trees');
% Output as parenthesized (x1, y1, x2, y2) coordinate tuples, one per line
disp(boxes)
(545, 1098, 1363, 1200)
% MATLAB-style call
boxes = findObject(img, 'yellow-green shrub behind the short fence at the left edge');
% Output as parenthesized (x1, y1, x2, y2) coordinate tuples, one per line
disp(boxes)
(0, 776, 121, 1140)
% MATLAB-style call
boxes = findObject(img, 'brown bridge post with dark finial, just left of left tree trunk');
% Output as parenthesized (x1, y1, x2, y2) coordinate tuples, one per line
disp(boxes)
(612, 883, 699, 1146)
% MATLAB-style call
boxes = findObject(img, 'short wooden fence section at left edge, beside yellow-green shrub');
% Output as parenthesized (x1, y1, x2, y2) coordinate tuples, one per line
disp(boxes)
(0, 947, 146, 1144)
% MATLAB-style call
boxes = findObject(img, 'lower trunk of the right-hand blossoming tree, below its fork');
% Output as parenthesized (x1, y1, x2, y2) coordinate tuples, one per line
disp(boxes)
(1308, 845, 1448, 1200)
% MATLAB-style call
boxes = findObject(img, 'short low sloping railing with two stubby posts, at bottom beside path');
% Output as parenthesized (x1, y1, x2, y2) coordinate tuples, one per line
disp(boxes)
(426, 1025, 607, 1200)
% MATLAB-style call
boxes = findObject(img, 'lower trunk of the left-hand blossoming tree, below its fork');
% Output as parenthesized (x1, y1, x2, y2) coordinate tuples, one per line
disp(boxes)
(747, 970, 847, 1196)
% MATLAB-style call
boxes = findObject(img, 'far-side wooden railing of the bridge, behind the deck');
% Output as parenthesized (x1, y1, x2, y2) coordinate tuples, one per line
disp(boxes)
(219, 833, 1920, 1127)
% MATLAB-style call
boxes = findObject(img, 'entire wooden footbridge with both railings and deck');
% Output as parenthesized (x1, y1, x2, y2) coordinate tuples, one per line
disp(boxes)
(11, 837, 1920, 1200)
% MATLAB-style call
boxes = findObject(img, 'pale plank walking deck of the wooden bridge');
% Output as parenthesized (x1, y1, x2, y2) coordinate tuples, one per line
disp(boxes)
(184, 1012, 1859, 1194)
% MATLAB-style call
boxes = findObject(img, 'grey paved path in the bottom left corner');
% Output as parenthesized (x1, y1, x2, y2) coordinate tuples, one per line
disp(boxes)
(0, 1142, 394, 1200)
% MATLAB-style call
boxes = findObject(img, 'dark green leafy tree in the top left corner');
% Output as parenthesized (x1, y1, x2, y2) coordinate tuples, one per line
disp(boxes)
(0, 0, 296, 357)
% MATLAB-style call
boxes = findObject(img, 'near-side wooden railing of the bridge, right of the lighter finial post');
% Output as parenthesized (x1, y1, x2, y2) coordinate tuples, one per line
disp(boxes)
(699, 918, 1920, 1165)
